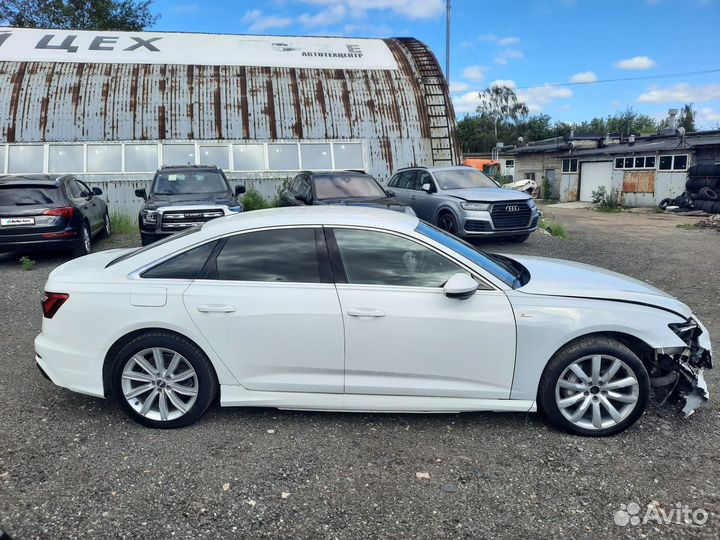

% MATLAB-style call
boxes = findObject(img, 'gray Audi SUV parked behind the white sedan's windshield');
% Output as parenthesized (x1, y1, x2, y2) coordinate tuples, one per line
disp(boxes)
(388, 166, 540, 242)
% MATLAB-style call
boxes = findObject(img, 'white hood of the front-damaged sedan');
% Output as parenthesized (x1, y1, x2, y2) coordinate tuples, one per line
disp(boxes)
(505, 255, 692, 318)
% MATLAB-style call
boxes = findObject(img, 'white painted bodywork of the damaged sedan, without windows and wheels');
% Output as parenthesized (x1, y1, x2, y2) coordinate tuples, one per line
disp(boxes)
(35, 206, 710, 418)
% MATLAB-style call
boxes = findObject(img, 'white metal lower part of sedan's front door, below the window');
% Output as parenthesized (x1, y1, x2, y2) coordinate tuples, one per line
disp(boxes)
(337, 284, 515, 399)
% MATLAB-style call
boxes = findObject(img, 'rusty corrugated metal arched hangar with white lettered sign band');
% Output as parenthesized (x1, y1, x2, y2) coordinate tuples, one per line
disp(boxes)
(0, 28, 459, 210)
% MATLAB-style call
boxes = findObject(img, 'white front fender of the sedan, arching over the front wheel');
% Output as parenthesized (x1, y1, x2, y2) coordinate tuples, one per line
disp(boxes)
(506, 291, 685, 399)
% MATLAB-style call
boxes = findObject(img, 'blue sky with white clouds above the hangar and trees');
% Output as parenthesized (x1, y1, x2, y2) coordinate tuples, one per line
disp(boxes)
(153, 0, 720, 128)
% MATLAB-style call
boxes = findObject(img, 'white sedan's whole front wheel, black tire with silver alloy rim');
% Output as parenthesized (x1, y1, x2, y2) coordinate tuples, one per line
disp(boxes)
(538, 337, 650, 437)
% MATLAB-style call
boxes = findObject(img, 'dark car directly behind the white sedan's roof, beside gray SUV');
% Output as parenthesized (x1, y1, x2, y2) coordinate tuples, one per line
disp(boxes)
(280, 171, 415, 215)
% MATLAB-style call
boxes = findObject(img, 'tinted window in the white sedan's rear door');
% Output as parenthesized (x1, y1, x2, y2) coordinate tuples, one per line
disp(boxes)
(217, 229, 321, 283)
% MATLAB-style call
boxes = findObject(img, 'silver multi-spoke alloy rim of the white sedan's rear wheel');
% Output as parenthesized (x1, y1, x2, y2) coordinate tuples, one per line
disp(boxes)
(121, 347, 199, 422)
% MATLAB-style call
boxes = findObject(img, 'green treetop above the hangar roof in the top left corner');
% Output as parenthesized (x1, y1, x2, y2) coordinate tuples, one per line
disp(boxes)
(0, 0, 160, 31)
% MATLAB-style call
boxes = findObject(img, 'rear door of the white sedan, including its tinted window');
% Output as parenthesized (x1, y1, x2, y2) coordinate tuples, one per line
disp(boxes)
(183, 227, 344, 393)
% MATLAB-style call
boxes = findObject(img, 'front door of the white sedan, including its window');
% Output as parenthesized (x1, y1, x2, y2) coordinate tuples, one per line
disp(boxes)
(326, 227, 516, 399)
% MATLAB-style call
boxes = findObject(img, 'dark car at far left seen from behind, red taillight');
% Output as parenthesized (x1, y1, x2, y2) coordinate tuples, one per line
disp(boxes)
(0, 175, 110, 256)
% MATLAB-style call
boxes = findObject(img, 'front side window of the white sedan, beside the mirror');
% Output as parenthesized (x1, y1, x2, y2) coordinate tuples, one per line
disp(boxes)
(334, 229, 467, 287)
